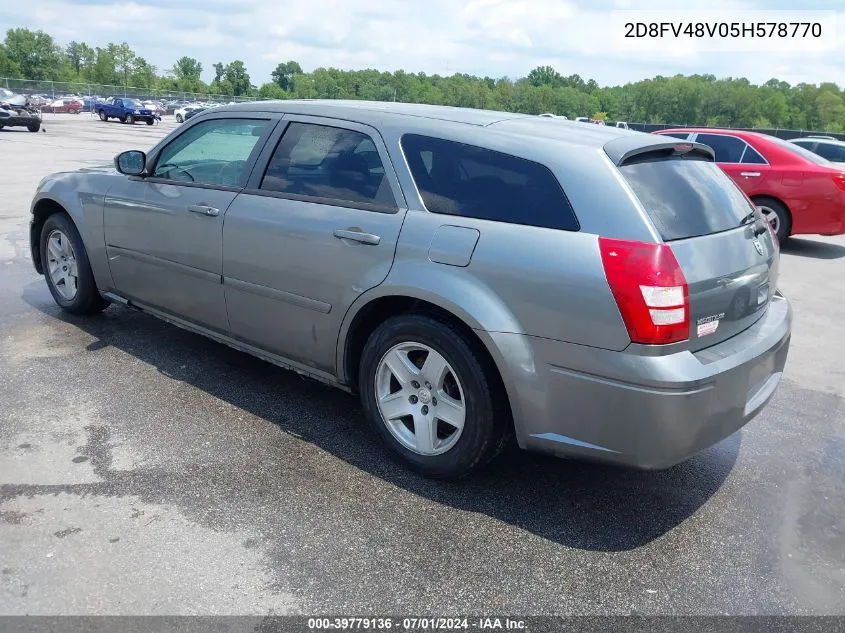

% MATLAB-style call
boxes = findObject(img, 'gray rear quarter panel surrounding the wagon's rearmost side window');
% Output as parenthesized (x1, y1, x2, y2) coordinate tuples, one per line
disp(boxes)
(340, 122, 636, 350)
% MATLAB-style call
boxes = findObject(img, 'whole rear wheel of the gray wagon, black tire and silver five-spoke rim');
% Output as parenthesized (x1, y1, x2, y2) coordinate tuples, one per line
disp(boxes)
(359, 315, 511, 479)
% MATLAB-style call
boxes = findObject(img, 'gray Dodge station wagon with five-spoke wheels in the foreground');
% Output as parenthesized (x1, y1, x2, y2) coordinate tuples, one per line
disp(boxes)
(31, 101, 792, 477)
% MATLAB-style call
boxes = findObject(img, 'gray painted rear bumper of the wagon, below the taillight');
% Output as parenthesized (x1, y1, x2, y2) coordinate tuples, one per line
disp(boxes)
(493, 295, 792, 469)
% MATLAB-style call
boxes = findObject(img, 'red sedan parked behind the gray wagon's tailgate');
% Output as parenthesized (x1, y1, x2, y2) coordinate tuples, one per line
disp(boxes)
(655, 128, 845, 242)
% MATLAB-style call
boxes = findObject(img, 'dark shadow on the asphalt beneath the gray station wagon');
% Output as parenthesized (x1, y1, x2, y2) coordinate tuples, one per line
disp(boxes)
(18, 280, 741, 552)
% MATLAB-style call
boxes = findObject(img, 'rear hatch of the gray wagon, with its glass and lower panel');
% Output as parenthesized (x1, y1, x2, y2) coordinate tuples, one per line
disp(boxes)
(619, 143, 779, 351)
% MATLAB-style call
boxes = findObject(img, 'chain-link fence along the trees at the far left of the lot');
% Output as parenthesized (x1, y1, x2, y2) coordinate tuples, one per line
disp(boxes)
(0, 77, 257, 103)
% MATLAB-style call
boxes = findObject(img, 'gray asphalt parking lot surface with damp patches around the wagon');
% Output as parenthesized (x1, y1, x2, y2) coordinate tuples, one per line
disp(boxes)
(0, 114, 845, 615)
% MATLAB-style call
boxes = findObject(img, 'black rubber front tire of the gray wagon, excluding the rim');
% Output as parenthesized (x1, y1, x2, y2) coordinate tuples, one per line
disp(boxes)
(40, 213, 109, 315)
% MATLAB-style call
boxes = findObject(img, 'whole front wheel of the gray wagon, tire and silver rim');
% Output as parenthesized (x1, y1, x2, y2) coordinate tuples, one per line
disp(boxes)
(40, 213, 109, 314)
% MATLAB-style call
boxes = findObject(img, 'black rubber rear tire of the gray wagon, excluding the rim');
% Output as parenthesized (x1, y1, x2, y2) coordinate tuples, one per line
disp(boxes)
(358, 314, 513, 479)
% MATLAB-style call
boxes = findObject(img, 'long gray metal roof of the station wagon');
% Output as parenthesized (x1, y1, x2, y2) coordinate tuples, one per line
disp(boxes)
(215, 99, 665, 151)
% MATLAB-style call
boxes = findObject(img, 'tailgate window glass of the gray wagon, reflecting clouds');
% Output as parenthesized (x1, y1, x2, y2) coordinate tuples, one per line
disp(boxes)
(619, 158, 753, 241)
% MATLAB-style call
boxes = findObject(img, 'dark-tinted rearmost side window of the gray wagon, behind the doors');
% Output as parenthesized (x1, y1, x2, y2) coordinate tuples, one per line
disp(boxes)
(402, 134, 579, 231)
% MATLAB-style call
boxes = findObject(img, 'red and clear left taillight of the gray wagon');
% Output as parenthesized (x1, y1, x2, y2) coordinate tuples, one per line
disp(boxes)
(599, 237, 690, 345)
